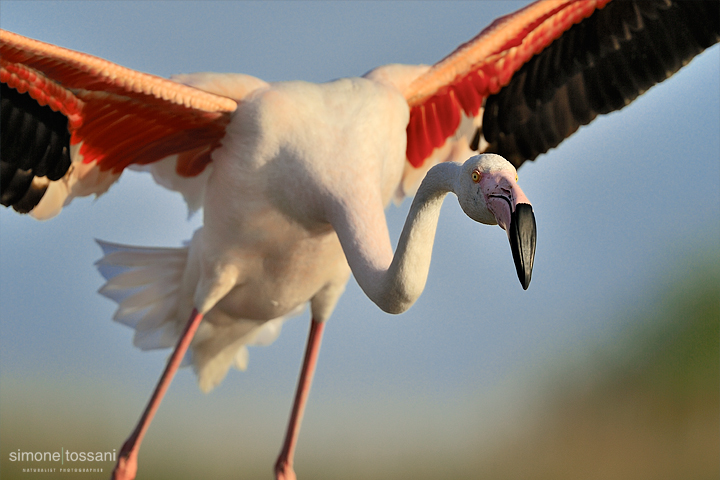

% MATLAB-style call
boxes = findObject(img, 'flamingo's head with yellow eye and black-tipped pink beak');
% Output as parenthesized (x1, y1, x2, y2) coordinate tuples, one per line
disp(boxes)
(455, 153, 537, 290)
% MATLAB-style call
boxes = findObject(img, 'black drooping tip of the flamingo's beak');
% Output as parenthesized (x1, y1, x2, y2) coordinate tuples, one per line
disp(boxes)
(508, 203, 537, 290)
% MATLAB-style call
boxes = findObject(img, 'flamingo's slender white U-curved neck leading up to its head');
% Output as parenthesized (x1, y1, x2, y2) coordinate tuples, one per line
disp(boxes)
(351, 162, 461, 313)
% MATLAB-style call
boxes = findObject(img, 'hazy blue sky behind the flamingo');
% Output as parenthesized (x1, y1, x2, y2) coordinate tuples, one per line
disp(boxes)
(0, 1, 720, 476)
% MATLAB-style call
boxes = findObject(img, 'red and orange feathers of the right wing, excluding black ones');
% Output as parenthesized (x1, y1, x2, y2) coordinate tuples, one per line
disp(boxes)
(404, 0, 610, 168)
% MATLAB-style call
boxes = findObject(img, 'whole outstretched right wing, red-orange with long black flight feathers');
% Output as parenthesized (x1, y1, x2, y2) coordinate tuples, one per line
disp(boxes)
(404, 0, 720, 195)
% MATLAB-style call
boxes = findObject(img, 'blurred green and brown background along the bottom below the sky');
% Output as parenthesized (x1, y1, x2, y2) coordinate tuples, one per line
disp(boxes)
(0, 251, 720, 480)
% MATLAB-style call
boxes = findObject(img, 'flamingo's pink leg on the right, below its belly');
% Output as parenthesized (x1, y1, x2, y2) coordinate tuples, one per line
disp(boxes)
(275, 319, 325, 480)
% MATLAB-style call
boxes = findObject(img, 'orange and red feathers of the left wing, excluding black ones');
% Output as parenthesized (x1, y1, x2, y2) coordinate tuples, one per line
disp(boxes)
(0, 31, 237, 176)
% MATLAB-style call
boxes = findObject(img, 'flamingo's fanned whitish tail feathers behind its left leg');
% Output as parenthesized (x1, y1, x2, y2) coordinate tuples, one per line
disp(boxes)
(95, 240, 292, 392)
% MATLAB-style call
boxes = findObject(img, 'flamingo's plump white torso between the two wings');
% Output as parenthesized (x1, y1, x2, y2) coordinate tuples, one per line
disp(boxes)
(186, 79, 407, 383)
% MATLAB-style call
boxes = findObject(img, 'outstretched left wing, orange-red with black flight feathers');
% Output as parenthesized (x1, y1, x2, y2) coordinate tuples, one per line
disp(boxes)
(0, 30, 237, 218)
